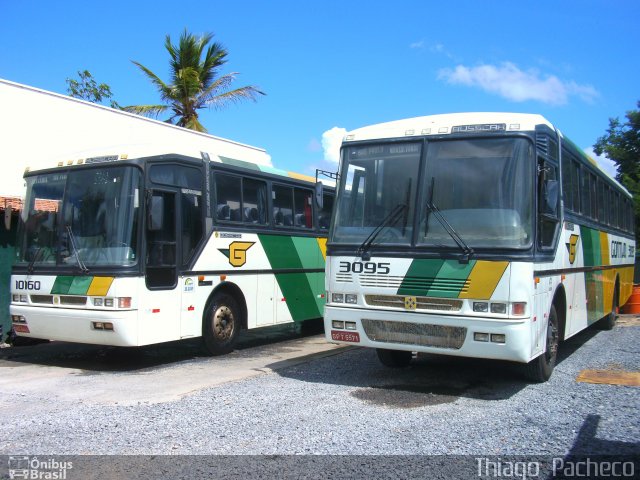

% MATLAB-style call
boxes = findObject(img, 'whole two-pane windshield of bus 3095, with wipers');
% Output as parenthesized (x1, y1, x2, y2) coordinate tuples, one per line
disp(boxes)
(331, 138, 535, 249)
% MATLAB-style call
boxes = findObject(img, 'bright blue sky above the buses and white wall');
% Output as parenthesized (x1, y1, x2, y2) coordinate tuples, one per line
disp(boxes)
(0, 0, 640, 178)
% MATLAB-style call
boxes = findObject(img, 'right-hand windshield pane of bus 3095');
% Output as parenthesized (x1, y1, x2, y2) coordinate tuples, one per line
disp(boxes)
(418, 138, 535, 248)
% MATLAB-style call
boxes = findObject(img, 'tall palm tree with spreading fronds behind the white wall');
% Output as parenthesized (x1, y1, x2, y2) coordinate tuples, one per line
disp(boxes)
(123, 30, 264, 132)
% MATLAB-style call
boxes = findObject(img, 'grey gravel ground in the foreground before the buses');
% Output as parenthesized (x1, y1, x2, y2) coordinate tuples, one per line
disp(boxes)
(0, 318, 640, 462)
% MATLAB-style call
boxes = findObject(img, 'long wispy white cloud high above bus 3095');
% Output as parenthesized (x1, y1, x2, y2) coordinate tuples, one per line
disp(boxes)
(438, 62, 599, 105)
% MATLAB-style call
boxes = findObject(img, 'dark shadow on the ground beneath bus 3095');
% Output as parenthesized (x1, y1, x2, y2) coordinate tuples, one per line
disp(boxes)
(277, 322, 599, 408)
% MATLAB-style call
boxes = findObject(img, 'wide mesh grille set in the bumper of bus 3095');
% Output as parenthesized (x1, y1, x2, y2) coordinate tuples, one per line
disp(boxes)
(362, 319, 467, 350)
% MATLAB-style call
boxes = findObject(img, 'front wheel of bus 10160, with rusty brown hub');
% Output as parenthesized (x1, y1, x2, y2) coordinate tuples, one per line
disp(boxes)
(202, 293, 240, 355)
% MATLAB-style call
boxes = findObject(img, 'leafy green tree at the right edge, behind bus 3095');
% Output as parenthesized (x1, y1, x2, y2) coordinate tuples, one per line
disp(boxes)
(593, 101, 640, 232)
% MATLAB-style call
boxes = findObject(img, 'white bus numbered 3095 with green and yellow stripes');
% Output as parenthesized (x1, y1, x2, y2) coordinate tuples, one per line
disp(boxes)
(324, 113, 635, 381)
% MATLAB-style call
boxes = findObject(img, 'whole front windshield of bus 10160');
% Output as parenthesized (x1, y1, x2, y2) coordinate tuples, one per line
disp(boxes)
(16, 167, 141, 270)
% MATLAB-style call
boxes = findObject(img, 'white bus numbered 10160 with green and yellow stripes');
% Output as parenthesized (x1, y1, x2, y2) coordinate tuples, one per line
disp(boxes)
(10, 146, 333, 354)
